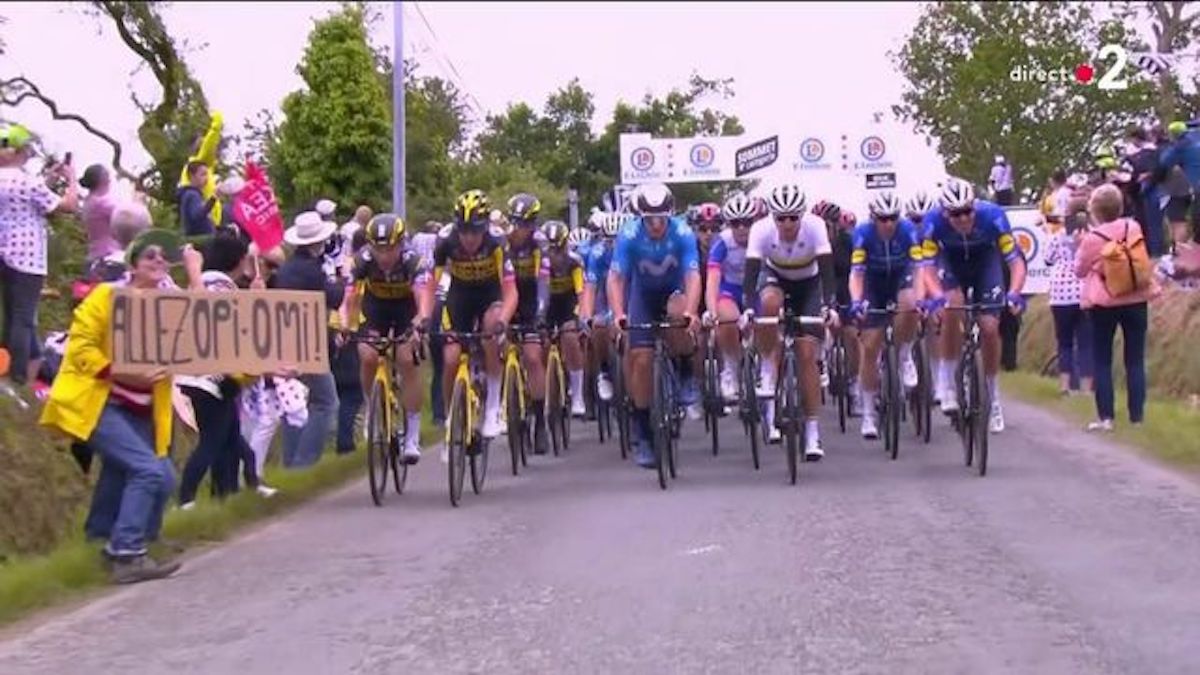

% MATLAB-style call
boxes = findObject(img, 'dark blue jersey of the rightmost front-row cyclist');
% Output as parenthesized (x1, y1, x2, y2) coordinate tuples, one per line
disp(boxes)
(922, 199, 1021, 264)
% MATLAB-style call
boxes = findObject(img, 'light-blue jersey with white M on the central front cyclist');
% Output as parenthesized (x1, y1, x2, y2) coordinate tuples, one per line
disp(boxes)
(612, 216, 700, 292)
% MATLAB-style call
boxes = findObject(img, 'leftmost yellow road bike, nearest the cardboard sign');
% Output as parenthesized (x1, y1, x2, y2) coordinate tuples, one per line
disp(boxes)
(349, 329, 421, 506)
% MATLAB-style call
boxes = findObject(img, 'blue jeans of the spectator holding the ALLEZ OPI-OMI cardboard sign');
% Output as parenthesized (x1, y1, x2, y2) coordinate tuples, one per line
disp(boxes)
(88, 402, 175, 556)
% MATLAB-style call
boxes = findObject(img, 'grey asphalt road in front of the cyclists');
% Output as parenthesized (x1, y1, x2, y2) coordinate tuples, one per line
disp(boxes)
(0, 402, 1200, 675)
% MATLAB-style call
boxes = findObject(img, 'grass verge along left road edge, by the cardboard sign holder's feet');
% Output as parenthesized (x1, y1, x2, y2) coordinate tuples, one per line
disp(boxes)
(0, 401, 443, 626)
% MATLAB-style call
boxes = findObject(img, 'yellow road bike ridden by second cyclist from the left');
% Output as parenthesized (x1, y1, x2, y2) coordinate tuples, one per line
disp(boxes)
(443, 330, 497, 506)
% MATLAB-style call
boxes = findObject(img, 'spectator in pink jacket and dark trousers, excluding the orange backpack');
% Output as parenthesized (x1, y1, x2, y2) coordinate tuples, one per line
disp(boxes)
(1075, 185, 1160, 431)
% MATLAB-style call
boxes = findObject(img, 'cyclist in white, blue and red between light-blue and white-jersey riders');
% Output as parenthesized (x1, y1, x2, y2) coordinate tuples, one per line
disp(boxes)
(703, 192, 758, 400)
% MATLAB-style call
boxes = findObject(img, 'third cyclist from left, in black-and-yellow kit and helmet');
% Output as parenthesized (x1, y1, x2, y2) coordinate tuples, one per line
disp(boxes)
(504, 192, 550, 455)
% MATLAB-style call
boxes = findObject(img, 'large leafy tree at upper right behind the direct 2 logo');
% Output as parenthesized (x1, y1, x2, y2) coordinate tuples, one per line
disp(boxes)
(890, 2, 1152, 195)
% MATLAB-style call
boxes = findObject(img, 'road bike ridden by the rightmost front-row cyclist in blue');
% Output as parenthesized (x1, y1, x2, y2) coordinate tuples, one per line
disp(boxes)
(946, 303, 1008, 477)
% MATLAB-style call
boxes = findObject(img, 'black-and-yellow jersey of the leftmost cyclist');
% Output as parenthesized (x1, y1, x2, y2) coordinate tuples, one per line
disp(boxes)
(350, 247, 430, 334)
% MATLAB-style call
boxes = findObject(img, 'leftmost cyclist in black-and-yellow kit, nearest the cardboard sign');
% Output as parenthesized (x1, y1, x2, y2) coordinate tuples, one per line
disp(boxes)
(348, 214, 432, 464)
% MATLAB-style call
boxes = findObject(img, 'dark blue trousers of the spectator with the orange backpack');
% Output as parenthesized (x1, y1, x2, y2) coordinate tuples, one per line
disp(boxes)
(1090, 303, 1150, 424)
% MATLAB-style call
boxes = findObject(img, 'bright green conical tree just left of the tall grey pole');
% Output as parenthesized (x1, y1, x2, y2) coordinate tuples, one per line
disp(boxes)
(265, 4, 392, 211)
